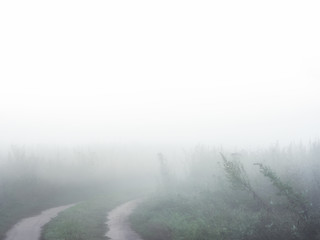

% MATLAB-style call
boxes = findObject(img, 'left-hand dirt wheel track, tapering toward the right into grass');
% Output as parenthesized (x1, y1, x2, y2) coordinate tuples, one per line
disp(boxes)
(5, 204, 74, 240)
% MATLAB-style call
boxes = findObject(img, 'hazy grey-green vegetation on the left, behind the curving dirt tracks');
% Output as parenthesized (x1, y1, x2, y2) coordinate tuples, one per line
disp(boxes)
(0, 146, 151, 239)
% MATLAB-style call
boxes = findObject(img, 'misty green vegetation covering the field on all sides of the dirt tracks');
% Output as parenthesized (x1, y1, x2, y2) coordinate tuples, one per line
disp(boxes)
(0, 142, 320, 240)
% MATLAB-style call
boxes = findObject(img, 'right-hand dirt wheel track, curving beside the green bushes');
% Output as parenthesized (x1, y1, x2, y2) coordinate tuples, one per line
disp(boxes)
(106, 199, 142, 240)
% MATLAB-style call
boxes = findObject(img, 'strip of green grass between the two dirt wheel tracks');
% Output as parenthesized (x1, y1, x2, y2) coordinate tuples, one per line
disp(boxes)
(41, 193, 140, 240)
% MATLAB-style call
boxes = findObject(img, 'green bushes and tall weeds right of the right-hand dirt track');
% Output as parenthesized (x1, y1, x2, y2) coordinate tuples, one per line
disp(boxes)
(131, 143, 320, 240)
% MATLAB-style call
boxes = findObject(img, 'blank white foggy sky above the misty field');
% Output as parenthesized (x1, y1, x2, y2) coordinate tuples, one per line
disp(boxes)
(0, 0, 320, 147)
